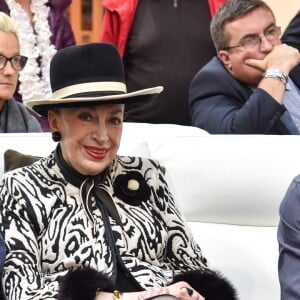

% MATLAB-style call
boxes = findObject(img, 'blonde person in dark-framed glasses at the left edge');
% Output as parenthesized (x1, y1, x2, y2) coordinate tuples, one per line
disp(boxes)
(0, 12, 42, 133)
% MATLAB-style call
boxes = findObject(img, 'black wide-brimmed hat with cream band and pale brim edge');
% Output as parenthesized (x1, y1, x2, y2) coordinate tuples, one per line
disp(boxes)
(26, 43, 163, 116)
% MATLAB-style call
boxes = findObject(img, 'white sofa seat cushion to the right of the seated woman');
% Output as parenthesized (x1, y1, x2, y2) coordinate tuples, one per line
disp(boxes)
(189, 222, 280, 300)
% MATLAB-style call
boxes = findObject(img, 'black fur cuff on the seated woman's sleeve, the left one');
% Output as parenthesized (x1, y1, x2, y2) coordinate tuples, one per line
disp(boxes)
(58, 268, 114, 300)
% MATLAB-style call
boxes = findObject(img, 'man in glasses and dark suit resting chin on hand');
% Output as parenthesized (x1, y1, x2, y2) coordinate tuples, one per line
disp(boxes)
(189, 0, 300, 134)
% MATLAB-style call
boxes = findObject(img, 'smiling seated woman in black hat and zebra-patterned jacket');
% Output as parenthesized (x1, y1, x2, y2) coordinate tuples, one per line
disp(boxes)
(0, 44, 237, 300)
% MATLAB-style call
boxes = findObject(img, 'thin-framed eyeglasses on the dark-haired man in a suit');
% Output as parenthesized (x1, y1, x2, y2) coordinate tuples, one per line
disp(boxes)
(223, 26, 281, 50)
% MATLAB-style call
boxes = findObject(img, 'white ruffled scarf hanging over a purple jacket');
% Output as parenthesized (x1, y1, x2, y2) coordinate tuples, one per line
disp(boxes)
(6, 0, 56, 103)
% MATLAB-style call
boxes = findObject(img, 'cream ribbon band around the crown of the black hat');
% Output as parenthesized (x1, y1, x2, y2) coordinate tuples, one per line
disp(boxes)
(53, 81, 127, 99)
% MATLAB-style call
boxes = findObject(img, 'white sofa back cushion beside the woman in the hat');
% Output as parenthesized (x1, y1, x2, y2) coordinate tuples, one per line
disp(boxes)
(152, 135, 300, 226)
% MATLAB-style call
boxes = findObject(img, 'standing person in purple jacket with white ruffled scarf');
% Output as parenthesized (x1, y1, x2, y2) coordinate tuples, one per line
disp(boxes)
(0, 0, 75, 131)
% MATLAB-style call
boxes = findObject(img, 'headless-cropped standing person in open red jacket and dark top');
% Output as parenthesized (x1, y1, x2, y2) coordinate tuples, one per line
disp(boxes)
(101, 0, 226, 125)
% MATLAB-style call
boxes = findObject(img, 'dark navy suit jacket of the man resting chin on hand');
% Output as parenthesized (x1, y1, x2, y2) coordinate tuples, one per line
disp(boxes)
(189, 57, 300, 134)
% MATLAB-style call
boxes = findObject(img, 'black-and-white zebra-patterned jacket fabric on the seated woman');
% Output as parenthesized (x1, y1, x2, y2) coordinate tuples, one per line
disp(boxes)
(0, 154, 206, 300)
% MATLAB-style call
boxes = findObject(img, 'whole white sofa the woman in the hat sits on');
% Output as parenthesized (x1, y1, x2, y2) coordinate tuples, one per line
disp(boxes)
(0, 123, 300, 300)
